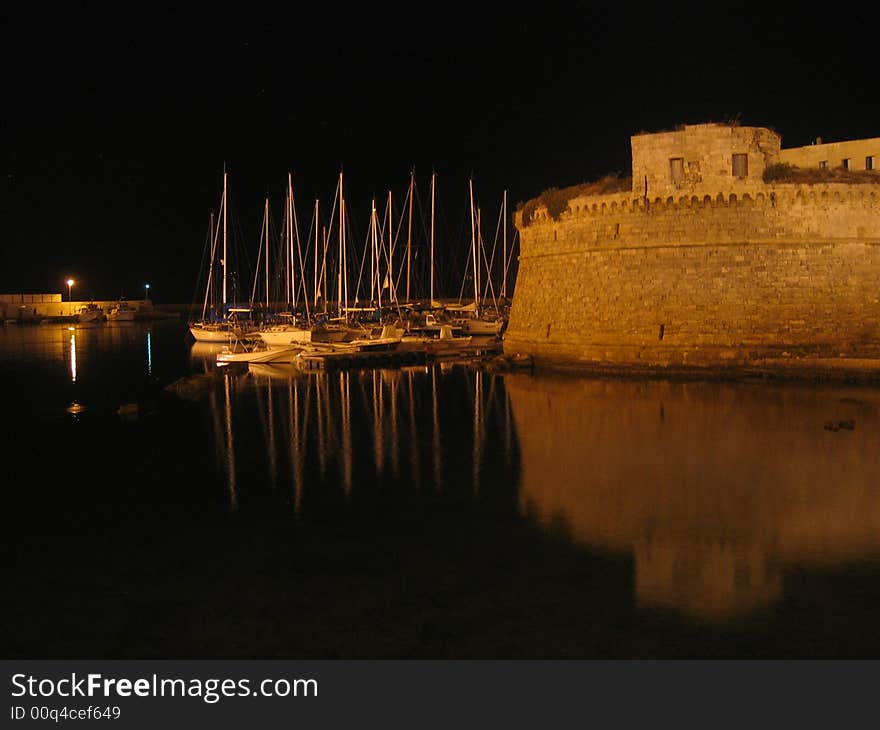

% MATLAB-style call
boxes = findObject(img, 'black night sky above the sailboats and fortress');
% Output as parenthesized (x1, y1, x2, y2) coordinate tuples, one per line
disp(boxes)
(0, 3, 880, 303)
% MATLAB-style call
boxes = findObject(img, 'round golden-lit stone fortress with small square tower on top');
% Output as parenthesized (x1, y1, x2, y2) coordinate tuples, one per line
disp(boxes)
(505, 124, 880, 367)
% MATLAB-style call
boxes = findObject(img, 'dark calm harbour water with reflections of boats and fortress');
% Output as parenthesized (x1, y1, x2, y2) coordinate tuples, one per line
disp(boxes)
(0, 321, 880, 658)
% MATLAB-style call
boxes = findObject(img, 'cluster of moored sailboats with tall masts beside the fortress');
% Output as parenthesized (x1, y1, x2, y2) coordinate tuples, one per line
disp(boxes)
(189, 172, 512, 368)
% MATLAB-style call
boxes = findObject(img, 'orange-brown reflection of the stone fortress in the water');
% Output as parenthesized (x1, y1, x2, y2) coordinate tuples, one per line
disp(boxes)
(505, 376, 880, 620)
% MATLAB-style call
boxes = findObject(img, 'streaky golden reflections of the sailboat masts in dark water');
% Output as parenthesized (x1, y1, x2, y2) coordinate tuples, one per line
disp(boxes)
(199, 362, 516, 513)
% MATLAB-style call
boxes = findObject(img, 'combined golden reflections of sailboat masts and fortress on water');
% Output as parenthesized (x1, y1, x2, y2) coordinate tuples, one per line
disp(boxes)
(194, 350, 880, 622)
